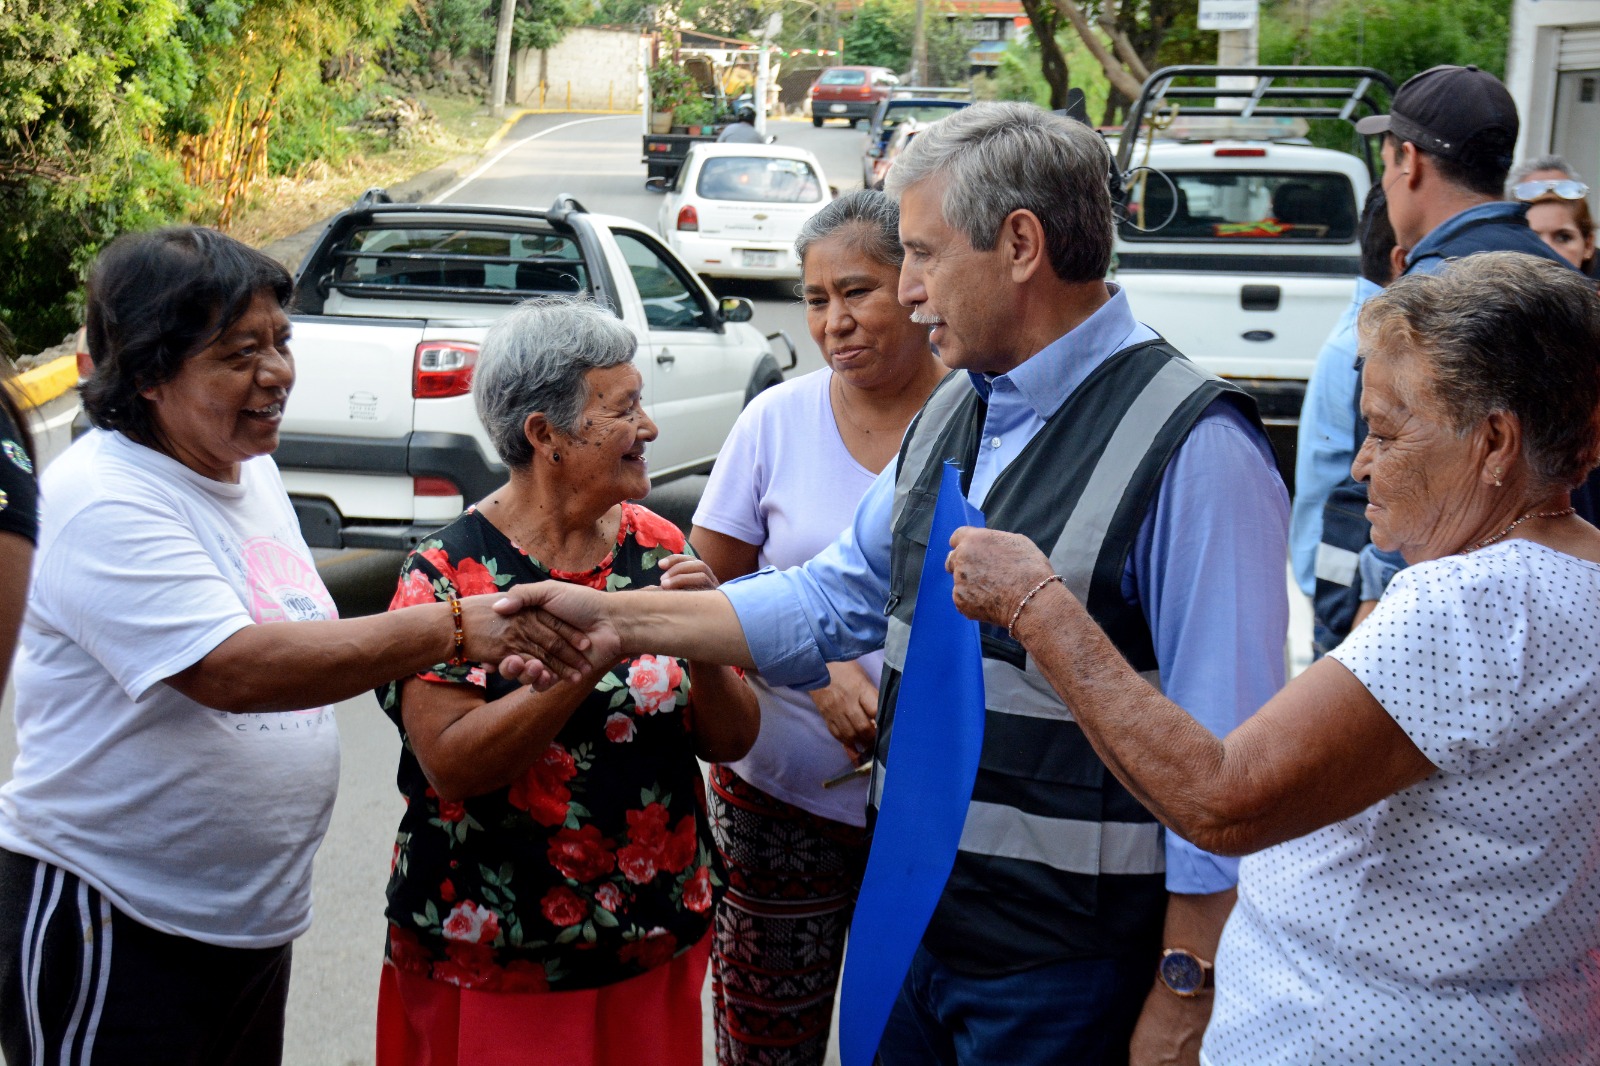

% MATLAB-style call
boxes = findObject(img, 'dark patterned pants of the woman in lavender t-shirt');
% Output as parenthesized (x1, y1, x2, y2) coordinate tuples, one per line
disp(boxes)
(710, 765, 867, 1066)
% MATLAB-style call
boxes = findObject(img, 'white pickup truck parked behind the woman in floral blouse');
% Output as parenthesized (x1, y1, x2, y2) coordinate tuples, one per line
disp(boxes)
(275, 190, 794, 549)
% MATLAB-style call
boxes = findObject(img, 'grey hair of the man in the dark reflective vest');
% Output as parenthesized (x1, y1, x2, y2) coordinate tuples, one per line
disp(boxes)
(885, 101, 1112, 282)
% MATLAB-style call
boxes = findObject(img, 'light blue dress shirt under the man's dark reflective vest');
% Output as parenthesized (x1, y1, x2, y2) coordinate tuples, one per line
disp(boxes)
(722, 287, 1288, 893)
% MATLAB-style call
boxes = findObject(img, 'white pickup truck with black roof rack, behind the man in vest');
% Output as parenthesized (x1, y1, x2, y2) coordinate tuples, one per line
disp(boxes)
(1114, 67, 1394, 487)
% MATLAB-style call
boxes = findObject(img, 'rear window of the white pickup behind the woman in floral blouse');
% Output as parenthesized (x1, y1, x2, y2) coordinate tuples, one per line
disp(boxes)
(330, 226, 589, 299)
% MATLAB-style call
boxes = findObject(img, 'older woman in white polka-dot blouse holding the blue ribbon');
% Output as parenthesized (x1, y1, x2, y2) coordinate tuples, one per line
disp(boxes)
(947, 253, 1600, 1066)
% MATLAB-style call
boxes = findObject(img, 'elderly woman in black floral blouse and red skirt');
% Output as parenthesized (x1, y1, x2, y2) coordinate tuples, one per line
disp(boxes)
(378, 301, 760, 1066)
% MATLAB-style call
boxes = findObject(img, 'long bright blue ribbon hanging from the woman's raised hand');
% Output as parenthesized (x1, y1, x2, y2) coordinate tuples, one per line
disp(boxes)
(838, 463, 984, 1066)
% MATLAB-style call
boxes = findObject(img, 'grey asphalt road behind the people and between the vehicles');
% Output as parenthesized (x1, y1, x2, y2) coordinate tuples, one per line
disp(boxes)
(0, 115, 1310, 1066)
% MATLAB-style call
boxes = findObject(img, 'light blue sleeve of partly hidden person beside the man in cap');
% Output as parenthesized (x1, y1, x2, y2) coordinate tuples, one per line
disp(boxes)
(1290, 277, 1384, 595)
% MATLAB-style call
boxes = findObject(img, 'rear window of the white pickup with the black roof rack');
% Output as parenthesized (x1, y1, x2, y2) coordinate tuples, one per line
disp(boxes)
(1120, 170, 1357, 243)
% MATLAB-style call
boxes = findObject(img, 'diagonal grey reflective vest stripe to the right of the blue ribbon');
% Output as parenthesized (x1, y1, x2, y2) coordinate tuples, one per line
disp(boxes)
(1050, 359, 1206, 603)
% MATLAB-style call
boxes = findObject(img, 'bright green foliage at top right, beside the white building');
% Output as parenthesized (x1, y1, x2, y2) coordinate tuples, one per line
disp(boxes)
(1261, 0, 1510, 85)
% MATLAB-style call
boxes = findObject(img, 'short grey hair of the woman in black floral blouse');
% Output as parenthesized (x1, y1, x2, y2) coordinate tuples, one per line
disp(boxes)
(472, 296, 638, 467)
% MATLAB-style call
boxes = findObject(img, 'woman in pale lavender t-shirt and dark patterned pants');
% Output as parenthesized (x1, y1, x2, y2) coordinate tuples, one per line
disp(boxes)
(690, 190, 946, 1066)
